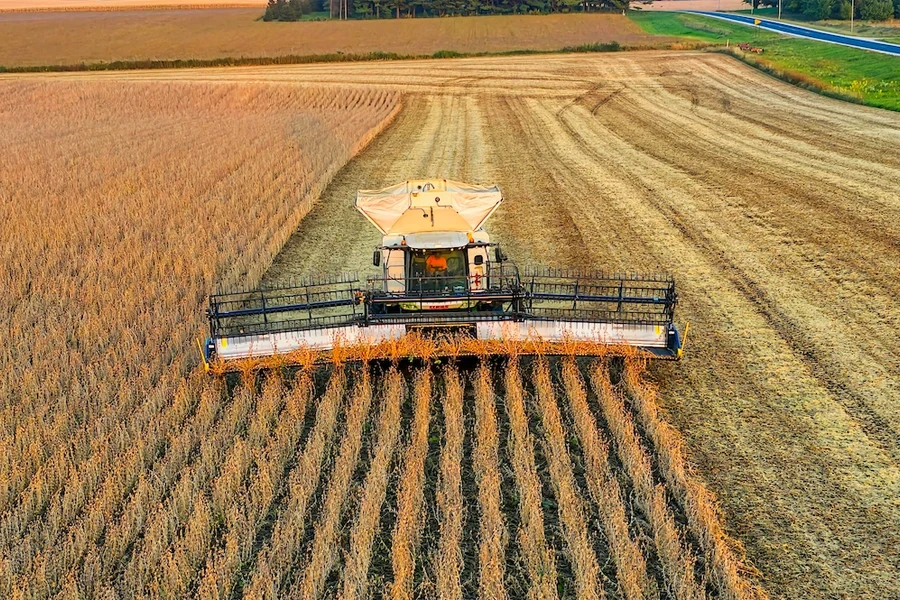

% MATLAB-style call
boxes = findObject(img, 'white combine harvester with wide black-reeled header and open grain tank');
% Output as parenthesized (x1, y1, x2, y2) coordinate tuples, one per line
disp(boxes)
(203, 179, 683, 371)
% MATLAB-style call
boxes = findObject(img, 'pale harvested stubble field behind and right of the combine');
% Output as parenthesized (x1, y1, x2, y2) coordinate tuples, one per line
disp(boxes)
(7, 53, 900, 598)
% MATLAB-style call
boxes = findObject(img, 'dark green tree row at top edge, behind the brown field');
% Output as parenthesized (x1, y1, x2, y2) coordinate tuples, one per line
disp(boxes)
(263, 0, 624, 21)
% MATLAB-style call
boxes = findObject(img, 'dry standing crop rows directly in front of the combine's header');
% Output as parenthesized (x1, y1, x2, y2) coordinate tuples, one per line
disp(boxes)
(135, 356, 762, 599)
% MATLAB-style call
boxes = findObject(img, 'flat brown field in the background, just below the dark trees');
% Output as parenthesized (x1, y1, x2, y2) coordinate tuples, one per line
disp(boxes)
(0, 9, 666, 67)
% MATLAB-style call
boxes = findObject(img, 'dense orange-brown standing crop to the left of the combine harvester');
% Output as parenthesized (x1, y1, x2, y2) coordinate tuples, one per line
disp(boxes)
(0, 81, 399, 597)
